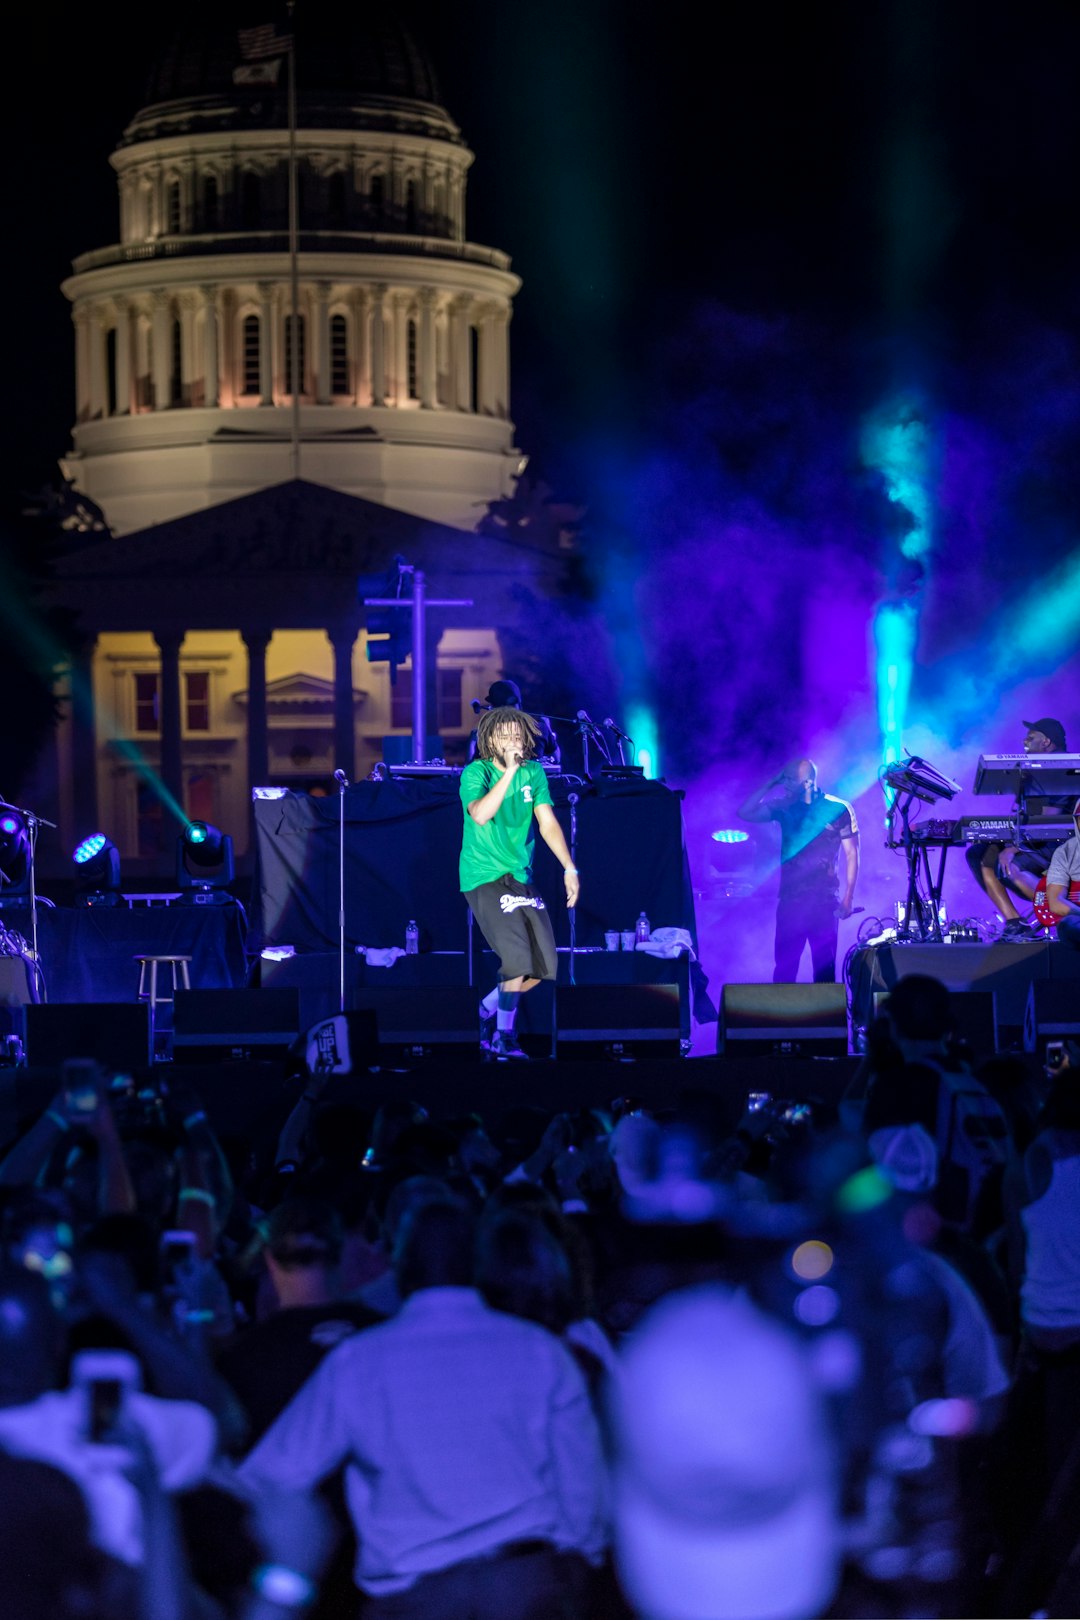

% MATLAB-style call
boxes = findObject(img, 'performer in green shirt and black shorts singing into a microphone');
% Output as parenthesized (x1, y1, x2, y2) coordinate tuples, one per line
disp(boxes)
(460, 708, 578, 1059)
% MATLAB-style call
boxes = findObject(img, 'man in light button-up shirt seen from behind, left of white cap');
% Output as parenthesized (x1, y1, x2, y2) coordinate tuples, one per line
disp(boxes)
(240, 1199, 606, 1620)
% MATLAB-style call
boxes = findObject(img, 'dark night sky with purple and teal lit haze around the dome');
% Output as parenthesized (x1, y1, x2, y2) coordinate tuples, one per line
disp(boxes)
(6, 0, 1080, 978)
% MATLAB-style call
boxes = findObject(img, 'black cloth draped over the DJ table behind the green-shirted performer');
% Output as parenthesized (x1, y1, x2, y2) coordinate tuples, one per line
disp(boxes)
(253, 774, 696, 951)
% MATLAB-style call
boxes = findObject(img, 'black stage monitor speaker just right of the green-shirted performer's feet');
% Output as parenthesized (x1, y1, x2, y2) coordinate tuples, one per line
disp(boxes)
(555, 985, 682, 1059)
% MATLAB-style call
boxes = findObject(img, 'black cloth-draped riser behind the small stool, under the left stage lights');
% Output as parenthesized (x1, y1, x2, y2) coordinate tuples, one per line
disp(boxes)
(30, 904, 246, 1001)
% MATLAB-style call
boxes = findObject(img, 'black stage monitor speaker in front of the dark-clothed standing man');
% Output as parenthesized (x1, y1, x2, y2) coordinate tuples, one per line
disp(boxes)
(716, 983, 847, 1058)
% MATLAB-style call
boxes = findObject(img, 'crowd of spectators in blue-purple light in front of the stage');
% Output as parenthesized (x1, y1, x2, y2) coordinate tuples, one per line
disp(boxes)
(0, 975, 1080, 1620)
